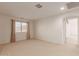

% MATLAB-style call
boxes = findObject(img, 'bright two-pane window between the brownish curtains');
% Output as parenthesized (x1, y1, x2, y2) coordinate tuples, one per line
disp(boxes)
(15, 21, 27, 32)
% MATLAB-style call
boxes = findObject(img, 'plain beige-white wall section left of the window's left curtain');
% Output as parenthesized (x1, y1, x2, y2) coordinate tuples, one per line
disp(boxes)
(0, 15, 11, 44)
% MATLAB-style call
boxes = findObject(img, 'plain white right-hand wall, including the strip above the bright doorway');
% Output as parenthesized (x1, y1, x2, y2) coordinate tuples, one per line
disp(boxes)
(35, 9, 79, 44)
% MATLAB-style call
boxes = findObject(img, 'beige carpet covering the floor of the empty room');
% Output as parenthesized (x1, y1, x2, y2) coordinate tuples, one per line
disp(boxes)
(0, 40, 79, 56)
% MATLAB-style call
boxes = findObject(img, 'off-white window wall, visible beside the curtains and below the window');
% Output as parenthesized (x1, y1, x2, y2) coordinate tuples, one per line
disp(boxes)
(0, 15, 33, 44)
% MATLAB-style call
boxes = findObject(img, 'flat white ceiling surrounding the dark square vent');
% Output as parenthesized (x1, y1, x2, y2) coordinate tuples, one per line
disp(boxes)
(0, 2, 67, 19)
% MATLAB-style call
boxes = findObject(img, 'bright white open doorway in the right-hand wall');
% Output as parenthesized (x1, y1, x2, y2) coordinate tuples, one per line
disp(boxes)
(65, 18, 78, 44)
